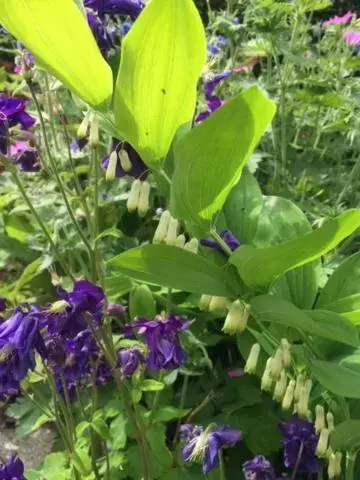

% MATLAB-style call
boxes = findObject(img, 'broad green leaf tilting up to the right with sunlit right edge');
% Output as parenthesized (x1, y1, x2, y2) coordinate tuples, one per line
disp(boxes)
(171, 87, 275, 222)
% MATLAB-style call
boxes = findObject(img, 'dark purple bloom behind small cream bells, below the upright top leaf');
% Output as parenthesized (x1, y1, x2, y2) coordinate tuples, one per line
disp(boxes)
(101, 139, 148, 179)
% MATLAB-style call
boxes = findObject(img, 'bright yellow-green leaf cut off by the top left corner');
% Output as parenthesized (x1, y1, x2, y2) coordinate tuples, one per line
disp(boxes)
(0, 0, 112, 109)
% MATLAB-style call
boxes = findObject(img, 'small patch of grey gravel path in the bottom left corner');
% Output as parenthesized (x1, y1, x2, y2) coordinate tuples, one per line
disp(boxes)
(0, 427, 54, 469)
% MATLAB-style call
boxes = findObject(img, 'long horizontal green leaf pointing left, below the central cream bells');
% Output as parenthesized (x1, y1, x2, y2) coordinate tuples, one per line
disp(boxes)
(108, 245, 240, 296)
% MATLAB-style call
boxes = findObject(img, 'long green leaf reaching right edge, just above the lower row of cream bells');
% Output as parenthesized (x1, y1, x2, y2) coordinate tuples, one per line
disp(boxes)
(250, 295, 359, 346)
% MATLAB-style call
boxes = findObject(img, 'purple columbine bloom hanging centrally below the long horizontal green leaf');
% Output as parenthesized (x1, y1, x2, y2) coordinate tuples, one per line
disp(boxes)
(124, 316, 188, 370)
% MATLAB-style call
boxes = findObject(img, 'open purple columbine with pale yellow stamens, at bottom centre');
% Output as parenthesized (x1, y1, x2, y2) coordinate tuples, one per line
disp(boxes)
(180, 424, 241, 475)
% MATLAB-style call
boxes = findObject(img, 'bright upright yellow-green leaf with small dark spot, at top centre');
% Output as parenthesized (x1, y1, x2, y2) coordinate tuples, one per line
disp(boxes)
(114, 0, 206, 166)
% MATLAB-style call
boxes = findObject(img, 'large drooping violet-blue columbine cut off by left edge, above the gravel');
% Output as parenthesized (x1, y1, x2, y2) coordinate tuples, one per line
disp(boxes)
(0, 308, 47, 395)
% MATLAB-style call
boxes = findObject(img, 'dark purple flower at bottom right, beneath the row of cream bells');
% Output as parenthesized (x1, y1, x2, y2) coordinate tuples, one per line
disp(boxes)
(280, 415, 320, 473)
